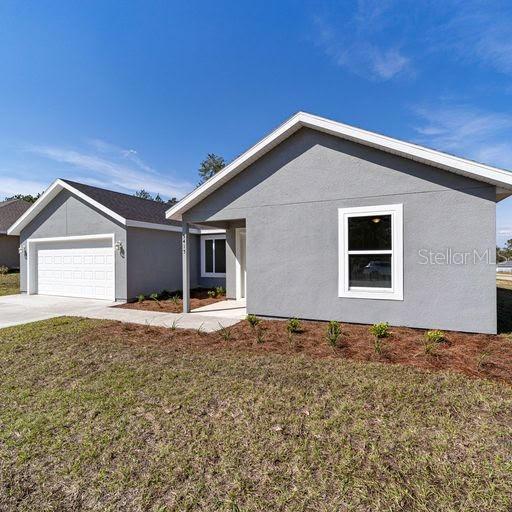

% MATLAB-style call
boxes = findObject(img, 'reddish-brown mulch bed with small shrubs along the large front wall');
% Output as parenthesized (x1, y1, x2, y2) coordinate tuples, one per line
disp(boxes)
(95, 320, 512, 384)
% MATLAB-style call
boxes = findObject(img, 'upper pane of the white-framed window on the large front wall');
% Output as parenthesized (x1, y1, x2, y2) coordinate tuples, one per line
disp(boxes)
(348, 215, 391, 251)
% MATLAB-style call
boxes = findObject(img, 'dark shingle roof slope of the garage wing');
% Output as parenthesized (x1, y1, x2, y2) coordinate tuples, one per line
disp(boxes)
(62, 179, 181, 227)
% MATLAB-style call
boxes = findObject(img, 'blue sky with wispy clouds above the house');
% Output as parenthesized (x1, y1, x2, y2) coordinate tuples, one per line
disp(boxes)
(0, 0, 512, 242)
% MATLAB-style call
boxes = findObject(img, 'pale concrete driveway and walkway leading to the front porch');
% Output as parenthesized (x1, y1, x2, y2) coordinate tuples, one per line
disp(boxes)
(0, 295, 246, 332)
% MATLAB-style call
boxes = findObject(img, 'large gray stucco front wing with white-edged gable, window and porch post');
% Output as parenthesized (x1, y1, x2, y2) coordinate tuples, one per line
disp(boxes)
(167, 112, 512, 333)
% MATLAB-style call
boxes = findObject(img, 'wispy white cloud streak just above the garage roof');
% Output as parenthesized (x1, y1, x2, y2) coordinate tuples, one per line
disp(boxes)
(26, 143, 193, 201)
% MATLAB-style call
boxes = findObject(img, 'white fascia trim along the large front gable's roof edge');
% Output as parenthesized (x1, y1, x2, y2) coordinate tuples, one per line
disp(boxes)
(166, 112, 512, 220)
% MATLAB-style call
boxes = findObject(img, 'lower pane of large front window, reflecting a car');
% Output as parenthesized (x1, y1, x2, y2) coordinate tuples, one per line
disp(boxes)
(348, 254, 391, 288)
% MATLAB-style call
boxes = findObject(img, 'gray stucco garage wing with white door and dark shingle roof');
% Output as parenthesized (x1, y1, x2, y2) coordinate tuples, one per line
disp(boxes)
(8, 179, 225, 300)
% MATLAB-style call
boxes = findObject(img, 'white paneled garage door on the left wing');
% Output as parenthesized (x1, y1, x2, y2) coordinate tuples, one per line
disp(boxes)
(34, 239, 115, 300)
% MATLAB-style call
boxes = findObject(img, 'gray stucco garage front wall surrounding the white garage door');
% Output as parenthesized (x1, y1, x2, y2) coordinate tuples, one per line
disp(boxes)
(20, 190, 127, 300)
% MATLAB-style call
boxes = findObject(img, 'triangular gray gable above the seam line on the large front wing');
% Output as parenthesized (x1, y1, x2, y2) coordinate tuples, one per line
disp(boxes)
(184, 128, 494, 220)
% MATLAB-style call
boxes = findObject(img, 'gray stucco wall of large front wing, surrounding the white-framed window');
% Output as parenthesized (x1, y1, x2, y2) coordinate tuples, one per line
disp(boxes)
(184, 129, 496, 332)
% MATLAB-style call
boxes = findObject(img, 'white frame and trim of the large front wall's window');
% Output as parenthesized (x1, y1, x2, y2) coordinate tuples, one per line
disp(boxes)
(338, 204, 404, 300)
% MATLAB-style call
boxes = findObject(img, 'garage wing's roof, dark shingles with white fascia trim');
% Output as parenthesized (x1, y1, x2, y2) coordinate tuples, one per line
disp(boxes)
(8, 179, 218, 235)
